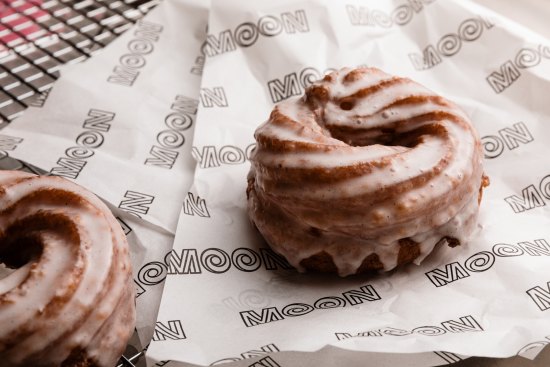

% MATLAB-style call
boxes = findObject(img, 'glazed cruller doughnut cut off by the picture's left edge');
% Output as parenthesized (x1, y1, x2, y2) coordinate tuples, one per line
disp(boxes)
(0, 171, 135, 367)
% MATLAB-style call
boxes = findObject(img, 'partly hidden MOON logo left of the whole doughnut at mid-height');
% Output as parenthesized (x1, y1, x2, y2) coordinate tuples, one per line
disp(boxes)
(191, 144, 256, 168)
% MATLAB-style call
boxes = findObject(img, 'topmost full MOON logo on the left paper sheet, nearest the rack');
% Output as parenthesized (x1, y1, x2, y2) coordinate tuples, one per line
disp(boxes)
(107, 20, 163, 87)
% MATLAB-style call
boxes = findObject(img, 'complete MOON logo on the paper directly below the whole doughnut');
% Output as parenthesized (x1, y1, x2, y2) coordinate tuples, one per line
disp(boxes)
(239, 284, 381, 327)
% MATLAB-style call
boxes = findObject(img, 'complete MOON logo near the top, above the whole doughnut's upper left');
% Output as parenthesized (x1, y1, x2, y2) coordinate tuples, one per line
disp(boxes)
(202, 10, 309, 57)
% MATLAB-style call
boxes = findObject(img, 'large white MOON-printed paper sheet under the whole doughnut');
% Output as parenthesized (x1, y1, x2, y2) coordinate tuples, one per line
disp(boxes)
(147, 0, 550, 366)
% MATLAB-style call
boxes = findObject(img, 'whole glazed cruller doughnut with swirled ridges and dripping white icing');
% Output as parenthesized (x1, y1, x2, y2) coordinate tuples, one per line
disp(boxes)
(247, 67, 488, 276)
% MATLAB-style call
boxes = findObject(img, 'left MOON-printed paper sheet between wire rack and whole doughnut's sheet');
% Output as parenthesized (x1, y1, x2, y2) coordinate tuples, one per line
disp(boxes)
(0, 0, 208, 348)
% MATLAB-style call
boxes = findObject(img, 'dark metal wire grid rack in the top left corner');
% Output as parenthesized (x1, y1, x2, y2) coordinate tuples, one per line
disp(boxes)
(0, 0, 160, 128)
